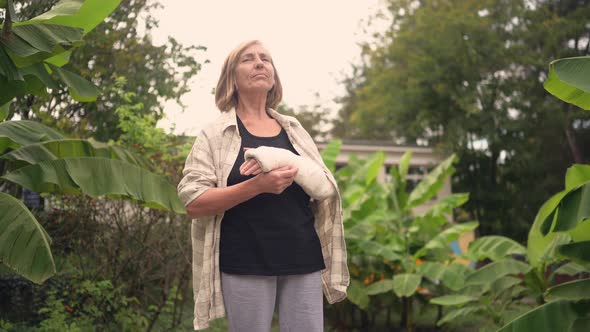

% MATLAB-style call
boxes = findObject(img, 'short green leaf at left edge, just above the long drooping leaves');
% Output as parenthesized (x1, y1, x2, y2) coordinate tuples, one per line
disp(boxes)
(0, 120, 66, 154)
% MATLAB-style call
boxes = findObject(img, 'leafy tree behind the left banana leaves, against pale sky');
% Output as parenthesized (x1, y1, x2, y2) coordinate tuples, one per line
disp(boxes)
(5, 0, 205, 142)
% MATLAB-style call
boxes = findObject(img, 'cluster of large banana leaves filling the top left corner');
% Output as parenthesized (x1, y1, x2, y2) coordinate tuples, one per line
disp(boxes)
(0, 0, 120, 107)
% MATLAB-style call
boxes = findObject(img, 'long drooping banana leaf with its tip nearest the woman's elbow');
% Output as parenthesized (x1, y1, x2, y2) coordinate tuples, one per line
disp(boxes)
(2, 157, 186, 214)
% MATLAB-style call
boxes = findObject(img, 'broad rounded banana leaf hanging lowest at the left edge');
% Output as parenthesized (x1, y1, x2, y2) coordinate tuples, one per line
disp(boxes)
(0, 192, 55, 284)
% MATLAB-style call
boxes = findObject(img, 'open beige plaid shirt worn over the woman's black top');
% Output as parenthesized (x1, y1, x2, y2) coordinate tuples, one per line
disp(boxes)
(178, 109, 350, 330)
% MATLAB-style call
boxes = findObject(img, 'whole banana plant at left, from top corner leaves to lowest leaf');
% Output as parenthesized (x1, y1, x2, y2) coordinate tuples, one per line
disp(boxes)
(0, 0, 186, 283)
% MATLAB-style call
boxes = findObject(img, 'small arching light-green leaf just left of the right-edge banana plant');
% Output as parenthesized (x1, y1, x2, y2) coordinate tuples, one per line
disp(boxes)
(466, 235, 526, 261)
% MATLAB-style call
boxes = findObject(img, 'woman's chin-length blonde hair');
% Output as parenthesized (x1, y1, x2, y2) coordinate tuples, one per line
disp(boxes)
(215, 40, 283, 112)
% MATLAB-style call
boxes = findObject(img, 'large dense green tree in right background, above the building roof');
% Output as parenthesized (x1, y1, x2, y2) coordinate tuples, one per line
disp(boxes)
(334, 0, 590, 241)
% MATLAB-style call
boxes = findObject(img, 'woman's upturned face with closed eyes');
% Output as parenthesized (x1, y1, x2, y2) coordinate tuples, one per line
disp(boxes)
(235, 44, 275, 93)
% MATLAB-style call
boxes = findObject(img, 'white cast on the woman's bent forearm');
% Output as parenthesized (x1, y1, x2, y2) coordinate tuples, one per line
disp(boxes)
(244, 146, 336, 201)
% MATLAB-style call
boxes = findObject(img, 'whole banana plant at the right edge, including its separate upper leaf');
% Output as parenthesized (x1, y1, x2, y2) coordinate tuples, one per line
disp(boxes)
(431, 57, 590, 331)
